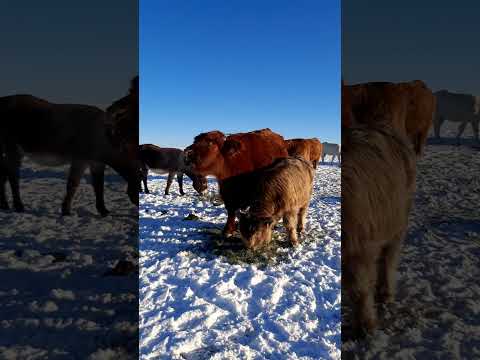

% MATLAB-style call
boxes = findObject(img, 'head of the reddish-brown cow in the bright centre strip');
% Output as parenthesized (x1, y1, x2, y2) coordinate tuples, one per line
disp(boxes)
(184, 131, 225, 176)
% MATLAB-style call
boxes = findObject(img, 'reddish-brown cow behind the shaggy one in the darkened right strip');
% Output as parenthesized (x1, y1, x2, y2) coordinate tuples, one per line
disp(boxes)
(342, 80, 435, 156)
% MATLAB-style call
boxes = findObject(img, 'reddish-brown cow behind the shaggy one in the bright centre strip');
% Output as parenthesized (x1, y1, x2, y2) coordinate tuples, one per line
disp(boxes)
(185, 129, 288, 236)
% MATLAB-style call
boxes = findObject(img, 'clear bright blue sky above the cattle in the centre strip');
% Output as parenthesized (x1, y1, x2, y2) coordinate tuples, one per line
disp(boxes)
(139, 0, 341, 147)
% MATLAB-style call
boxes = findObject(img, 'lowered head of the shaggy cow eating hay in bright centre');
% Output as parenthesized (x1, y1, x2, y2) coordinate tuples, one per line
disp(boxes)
(239, 213, 274, 250)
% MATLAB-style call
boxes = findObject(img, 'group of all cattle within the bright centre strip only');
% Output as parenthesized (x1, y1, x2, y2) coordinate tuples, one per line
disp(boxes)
(139, 129, 339, 249)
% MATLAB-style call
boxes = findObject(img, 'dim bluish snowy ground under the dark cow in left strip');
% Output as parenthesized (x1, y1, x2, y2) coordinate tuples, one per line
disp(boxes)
(0, 162, 138, 360)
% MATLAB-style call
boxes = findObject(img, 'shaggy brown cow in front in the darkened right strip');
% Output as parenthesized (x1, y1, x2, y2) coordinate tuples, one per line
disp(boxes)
(342, 123, 416, 332)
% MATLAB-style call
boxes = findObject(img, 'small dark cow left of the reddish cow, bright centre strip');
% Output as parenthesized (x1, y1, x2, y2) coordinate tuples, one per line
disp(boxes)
(139, 144, 208, 195)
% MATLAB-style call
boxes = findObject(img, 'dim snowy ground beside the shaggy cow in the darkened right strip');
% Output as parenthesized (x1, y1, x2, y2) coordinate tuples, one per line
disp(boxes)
(342, 123, 480, 359)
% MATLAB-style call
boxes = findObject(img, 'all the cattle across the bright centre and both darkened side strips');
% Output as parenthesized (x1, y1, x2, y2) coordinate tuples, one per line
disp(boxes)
(0, 76, 480, 338)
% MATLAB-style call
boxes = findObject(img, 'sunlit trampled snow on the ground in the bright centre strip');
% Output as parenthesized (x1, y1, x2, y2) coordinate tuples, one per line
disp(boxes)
(139, 165, 341, 360)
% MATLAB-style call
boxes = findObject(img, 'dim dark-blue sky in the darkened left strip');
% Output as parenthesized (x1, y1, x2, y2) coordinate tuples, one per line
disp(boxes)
(0, 0, 139, 108)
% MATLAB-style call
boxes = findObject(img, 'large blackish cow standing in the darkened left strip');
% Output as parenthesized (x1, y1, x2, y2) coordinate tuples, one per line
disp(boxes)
(0, 95, 138, 216)
